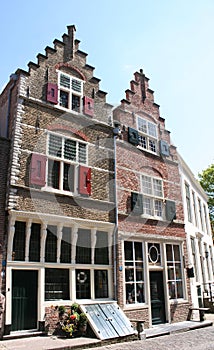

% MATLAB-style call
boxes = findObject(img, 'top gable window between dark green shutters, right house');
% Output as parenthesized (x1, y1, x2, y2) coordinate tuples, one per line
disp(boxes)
(138, 117, 157, 153)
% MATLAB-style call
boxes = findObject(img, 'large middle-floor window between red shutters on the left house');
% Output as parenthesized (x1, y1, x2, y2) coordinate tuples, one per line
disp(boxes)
(47, 134, 87, 192)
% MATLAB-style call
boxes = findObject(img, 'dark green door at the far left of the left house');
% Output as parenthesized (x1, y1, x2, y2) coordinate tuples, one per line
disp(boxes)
(11, 270, 38, 331)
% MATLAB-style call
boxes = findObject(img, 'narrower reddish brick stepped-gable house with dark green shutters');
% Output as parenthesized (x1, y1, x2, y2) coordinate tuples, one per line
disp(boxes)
(113, 70, 191, 326)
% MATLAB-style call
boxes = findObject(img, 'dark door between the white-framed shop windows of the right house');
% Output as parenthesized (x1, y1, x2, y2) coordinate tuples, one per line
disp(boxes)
(150, 271, 166, 325)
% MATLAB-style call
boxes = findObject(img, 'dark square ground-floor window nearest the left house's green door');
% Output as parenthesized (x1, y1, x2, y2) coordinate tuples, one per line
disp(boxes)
(45, 268, 70, 300)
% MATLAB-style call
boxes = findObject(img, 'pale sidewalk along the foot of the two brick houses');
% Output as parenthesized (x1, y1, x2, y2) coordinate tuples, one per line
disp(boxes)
(0, 314, 214, 350)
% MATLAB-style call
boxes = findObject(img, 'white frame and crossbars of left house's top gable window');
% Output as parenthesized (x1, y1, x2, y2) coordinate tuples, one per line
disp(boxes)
(58, 71, 84, 113)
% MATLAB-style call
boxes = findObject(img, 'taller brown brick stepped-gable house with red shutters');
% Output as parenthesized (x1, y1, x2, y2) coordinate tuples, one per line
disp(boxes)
(0, 26, 115, 334)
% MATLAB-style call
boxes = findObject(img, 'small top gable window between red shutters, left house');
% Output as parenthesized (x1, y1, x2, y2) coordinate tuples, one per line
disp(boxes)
(59, 72, 83, 113)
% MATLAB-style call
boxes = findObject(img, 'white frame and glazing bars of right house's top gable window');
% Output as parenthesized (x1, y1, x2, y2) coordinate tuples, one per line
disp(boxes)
(137, 116, 158, 154)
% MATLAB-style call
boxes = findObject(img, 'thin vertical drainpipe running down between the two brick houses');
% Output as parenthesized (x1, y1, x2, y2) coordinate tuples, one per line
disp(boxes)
(113, 123, 121, 300)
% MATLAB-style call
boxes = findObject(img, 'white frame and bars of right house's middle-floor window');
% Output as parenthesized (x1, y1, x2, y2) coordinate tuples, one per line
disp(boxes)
(141, 174, 165, 220)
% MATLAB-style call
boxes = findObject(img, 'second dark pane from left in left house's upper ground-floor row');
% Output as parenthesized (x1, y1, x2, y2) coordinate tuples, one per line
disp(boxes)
(29, 223, 41, 261)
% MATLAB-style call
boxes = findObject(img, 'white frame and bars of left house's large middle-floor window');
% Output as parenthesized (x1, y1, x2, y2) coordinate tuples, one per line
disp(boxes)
(45, 132, 88, 195)
